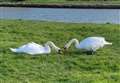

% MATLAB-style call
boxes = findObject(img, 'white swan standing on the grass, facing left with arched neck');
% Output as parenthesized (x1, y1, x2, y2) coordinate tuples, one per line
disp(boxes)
(64, 37, 112, 54)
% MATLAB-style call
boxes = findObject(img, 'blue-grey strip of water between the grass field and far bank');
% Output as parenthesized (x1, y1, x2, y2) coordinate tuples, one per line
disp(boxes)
(0, 7, 120, 24)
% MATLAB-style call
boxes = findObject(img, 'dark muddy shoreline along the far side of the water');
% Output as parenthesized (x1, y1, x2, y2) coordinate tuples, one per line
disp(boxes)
(0, 3, 120, 9)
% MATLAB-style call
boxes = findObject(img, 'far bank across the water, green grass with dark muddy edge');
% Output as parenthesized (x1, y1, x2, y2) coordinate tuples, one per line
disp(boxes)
(0, 0, 120, 9)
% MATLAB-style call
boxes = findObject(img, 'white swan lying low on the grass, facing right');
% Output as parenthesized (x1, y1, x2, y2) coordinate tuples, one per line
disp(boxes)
(10, 41, 61, 55)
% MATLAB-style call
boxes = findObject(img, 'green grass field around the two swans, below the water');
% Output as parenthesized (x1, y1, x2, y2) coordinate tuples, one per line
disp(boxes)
(0, 20, 120, 83)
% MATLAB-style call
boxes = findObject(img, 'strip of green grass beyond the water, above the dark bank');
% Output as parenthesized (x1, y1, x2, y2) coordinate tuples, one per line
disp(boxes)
(0, 0, 120, 4)
